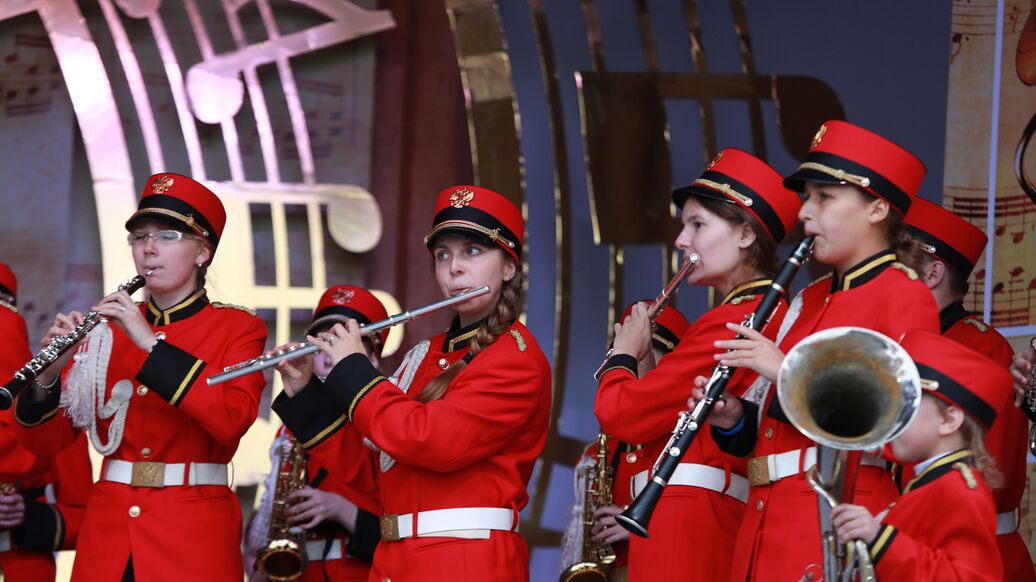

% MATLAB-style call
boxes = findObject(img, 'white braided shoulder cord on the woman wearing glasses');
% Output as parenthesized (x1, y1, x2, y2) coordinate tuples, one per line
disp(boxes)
(61, 323, 133, 457)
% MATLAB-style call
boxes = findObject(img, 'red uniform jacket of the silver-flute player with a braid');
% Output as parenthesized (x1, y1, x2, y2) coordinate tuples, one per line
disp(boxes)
(275, 322, 550, 580)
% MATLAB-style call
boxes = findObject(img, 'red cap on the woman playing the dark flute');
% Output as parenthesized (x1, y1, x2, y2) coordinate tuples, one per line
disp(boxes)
(672, 148, 802, 242)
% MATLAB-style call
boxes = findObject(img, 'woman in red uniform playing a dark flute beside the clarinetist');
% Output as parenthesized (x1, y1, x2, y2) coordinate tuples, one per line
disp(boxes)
(595, 149, 801, 580)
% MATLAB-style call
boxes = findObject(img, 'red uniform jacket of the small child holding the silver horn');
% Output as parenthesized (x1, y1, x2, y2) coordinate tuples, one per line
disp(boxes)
(870, 450, 1005, 582)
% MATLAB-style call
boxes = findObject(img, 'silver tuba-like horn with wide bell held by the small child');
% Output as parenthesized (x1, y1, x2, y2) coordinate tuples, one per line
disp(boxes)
(777, 327, 921, 582)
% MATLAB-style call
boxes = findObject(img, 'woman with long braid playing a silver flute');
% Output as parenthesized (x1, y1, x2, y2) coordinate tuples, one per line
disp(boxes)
(275, 185, 550, 581)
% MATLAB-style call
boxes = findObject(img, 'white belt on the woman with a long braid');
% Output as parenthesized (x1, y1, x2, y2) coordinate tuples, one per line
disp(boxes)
(381, 507, 518, 542)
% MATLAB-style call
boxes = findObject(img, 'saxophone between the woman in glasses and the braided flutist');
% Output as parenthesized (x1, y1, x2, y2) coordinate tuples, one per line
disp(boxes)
(256, 433, 308, 582)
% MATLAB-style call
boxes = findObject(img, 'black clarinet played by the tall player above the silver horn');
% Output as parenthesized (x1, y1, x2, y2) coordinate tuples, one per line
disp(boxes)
(615, 235, 815, 537)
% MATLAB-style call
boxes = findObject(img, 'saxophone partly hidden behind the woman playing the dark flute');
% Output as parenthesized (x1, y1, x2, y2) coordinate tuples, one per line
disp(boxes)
(559, 433, 615, 582)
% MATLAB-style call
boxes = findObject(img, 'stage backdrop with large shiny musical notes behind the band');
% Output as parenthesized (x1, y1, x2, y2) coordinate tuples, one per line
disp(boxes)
(0, 0, 1036, 580)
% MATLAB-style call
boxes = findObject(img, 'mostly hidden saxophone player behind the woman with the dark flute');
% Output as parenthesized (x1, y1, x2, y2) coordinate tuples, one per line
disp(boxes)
(562, 301, 690, 580)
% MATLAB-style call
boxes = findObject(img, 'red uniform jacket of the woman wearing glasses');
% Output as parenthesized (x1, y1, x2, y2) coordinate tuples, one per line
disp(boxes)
(16, 291, 266, 582)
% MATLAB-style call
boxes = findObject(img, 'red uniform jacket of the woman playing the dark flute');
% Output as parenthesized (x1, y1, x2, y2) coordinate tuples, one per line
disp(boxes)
(595, 280, 787, 580)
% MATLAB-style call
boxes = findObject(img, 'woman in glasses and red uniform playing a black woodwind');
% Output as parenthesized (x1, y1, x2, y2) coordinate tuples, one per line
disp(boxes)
(16, 174, 266, 582)
